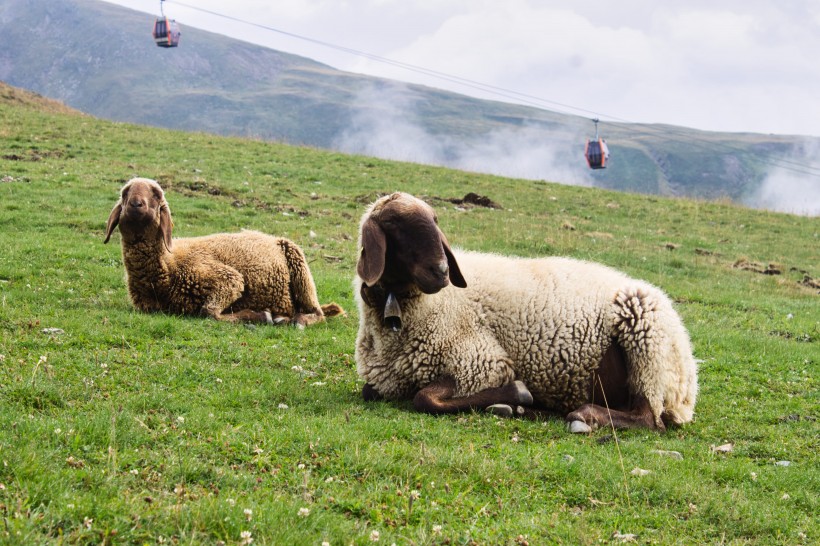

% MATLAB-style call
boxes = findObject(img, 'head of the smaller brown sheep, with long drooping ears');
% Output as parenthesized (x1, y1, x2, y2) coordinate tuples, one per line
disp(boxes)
(103, 178, 173, 250)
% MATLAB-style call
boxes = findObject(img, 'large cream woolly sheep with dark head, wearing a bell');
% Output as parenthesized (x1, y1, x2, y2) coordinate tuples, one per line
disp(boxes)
(354, 193, 698, 432)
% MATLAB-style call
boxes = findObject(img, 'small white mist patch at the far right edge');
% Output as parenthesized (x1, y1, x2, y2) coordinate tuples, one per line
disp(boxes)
(745, 140, 820, 216)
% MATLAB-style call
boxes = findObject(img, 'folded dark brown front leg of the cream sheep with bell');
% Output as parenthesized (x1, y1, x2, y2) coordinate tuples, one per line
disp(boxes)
(413, 377, 532, 415)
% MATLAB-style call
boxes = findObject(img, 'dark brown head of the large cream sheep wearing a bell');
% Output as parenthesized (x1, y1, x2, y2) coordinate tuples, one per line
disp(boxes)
(357, 193, 467, 294)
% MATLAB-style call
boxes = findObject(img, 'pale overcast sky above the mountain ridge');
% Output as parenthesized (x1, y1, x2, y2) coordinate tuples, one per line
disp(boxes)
(107, 0, 820, 136)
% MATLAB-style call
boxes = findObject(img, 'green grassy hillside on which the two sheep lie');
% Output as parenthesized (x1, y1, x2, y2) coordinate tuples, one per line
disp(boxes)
(0, 85, 820, 545)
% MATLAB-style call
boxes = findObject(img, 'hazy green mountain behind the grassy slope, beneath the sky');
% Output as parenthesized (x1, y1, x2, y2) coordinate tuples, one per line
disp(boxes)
(0, 0, 820, 214)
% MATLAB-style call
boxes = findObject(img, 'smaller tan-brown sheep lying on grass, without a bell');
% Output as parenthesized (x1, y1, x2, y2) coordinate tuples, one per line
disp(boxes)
(103, 178, 345, 328)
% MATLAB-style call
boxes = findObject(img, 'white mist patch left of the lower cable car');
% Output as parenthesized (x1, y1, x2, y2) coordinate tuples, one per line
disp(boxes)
(333, 85, 593, 186)
